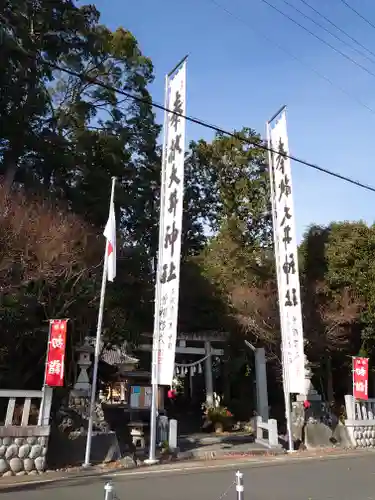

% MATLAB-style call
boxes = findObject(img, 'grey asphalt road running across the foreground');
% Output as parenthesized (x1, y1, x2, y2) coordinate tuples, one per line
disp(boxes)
(1, 453, 375, 500)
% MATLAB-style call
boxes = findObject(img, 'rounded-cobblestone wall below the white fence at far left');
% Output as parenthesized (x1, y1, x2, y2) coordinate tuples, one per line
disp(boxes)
(0, 425, 50, 477)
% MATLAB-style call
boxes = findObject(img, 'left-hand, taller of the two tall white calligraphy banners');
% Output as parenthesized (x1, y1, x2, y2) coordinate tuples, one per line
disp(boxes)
(153, 61, 186, 385)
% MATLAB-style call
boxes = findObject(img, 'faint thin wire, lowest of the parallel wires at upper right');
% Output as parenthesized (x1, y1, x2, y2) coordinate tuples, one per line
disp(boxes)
(208, 0, 375, 114)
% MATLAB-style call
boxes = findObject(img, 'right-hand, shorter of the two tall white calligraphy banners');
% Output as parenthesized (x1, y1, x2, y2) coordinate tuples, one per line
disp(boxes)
(268, 108, 305, 394)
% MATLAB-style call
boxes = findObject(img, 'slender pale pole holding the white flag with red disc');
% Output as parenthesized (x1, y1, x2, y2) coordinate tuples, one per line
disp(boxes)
(83, 177, 116, 467)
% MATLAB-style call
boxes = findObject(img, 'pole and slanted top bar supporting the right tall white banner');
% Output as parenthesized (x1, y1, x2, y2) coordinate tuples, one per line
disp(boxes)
(266, 105, 295, 452)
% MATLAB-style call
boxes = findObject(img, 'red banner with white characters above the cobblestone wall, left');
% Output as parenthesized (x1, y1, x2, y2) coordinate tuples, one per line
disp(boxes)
(45, 319, 68, 387)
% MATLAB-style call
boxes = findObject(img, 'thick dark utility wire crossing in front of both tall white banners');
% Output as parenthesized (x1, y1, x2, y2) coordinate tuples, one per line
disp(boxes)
(5, 33, 375, 193)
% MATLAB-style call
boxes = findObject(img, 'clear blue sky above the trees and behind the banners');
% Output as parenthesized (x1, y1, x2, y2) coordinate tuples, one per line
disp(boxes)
(94, 0, 375, 239)
